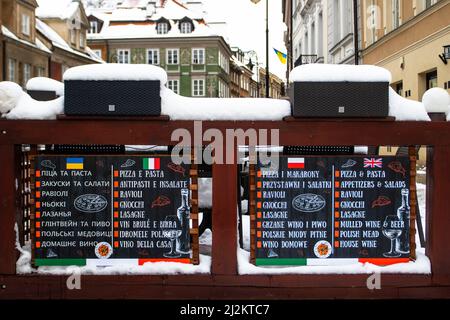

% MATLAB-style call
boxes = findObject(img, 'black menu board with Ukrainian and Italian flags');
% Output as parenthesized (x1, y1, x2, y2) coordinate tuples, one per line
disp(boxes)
(33, 156, 191, 266)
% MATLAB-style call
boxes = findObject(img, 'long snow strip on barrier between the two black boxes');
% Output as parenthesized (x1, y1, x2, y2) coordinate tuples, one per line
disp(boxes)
(161, 88, 291, 121)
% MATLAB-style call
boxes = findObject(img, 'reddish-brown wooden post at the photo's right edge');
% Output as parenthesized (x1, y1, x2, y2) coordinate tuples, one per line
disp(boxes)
(427, 146, 450, 278)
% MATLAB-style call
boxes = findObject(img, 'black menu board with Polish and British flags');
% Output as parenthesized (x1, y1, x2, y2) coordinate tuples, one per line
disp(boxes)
(254, 156, 410, 265)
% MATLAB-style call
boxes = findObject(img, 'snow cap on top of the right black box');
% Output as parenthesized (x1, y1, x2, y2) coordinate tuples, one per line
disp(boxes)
(289, 63, 391, 82)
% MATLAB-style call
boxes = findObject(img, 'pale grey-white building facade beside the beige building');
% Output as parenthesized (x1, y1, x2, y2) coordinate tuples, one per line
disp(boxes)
(283, 0, 361, 79)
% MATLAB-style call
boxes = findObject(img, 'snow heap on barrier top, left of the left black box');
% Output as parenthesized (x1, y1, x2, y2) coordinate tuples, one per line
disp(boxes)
(5, 93, 64, 120)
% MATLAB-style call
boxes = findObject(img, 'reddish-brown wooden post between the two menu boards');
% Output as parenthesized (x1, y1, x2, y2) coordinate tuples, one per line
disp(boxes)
(211, 162, 237, 275)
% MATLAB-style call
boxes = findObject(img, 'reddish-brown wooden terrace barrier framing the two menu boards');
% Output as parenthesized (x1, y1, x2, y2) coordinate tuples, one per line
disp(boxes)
(0, 119, 450, 299)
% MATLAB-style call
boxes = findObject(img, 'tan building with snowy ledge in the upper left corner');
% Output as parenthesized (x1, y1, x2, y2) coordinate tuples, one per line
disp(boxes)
(0, 0, 51, 87)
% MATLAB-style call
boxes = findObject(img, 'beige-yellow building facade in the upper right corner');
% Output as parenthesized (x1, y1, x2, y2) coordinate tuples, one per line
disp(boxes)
(362, 0, 450, 101)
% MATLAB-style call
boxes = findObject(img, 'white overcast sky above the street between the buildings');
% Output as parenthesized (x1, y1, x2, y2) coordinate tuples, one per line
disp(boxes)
(203, 0, 286, 79)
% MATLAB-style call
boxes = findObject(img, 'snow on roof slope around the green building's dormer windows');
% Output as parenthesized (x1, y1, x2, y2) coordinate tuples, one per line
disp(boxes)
(88, 20, 218, 40)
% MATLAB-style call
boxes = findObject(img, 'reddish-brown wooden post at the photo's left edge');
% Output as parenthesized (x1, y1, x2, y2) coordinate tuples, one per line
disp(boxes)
(0, 144, 16, 274)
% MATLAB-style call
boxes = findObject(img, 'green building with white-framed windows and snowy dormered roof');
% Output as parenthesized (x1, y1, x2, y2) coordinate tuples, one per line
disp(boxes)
(87, 0, 232, 97)
